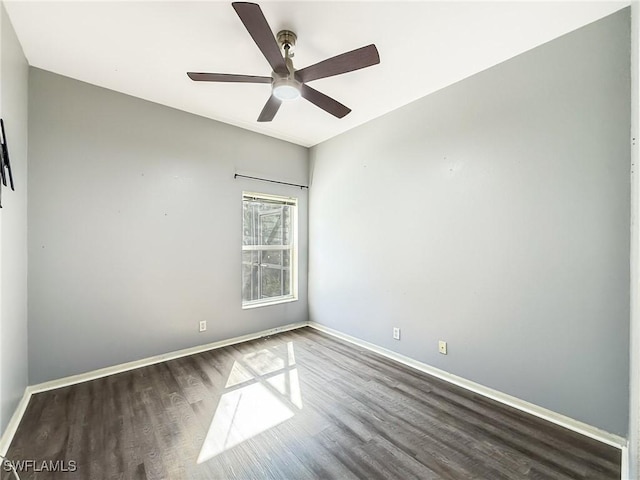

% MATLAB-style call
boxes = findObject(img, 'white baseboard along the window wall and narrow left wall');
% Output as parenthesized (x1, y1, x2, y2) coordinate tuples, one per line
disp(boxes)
(0, 322, 308, 456)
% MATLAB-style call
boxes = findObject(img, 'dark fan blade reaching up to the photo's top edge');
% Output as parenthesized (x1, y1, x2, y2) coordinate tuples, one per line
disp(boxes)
(231, 2, 289, 75)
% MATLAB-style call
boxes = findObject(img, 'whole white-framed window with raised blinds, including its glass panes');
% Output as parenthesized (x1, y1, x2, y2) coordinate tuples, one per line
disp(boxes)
(242, 192, 297, 308)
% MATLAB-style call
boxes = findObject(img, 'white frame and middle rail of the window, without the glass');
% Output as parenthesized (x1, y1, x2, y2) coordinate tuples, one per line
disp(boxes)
(240, 192, 298, 310)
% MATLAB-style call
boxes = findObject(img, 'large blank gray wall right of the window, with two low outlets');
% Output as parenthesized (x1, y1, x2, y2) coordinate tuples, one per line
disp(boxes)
(309, 9, 630, 435)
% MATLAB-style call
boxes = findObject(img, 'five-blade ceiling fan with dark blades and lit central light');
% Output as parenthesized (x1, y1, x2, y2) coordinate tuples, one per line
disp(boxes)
(187, 2, 380, 122)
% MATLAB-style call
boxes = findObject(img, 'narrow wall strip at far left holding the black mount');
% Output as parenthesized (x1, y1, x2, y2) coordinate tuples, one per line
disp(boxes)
(0, 4, 28, 432)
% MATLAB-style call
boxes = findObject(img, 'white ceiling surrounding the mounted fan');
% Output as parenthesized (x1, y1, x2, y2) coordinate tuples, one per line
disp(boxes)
(5, 0, 629, 146)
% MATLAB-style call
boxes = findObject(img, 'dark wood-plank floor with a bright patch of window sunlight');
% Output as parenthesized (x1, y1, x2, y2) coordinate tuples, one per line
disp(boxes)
(3, 328, 620, 480)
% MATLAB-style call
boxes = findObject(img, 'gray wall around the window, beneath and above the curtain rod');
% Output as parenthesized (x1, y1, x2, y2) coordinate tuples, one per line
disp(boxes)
(29, 68, 308, 384)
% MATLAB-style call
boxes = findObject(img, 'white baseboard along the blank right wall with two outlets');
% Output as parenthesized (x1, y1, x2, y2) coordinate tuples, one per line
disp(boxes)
(309, 322, 627, 452)
